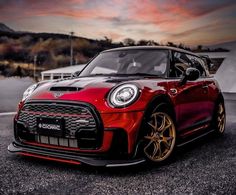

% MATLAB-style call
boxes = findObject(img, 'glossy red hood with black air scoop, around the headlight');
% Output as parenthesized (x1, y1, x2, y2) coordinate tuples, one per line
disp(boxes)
(27, 76, 166, 113)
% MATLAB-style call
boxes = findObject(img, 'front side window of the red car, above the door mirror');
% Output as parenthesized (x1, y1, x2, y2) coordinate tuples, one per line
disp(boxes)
(169, 52, 191, 78)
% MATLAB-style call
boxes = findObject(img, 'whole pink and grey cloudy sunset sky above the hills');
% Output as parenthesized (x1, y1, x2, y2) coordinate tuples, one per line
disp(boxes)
(0, 0, 236, 45)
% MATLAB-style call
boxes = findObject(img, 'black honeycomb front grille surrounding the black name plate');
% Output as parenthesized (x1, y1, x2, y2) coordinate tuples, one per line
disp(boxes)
(18, 101, 101, 148)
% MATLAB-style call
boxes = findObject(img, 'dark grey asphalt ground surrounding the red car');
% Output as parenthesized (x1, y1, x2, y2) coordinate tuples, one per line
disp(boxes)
(0, 77, 236, 195)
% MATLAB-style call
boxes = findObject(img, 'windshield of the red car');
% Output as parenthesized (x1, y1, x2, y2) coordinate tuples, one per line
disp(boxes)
(79, 49, 168, 76)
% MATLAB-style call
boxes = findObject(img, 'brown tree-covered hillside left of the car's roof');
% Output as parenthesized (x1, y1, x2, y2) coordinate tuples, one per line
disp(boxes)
(0, 24, 123, 76)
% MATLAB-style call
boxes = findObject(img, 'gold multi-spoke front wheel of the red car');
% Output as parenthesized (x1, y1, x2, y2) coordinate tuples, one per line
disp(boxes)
(144, 112, 176, 162)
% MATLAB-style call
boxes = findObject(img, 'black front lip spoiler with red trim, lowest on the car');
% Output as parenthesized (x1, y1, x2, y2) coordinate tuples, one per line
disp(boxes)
(7, 142, 146, 167)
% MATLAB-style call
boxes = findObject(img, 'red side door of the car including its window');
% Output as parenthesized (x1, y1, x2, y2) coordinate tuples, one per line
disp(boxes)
(169, 51, 210, 137)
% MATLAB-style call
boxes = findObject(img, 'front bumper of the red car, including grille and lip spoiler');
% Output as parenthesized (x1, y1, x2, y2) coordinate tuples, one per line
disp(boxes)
(8, 101, 145, 167)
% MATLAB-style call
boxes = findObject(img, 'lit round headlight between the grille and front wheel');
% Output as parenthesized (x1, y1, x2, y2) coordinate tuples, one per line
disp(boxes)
(108, 84, 139, 108)
